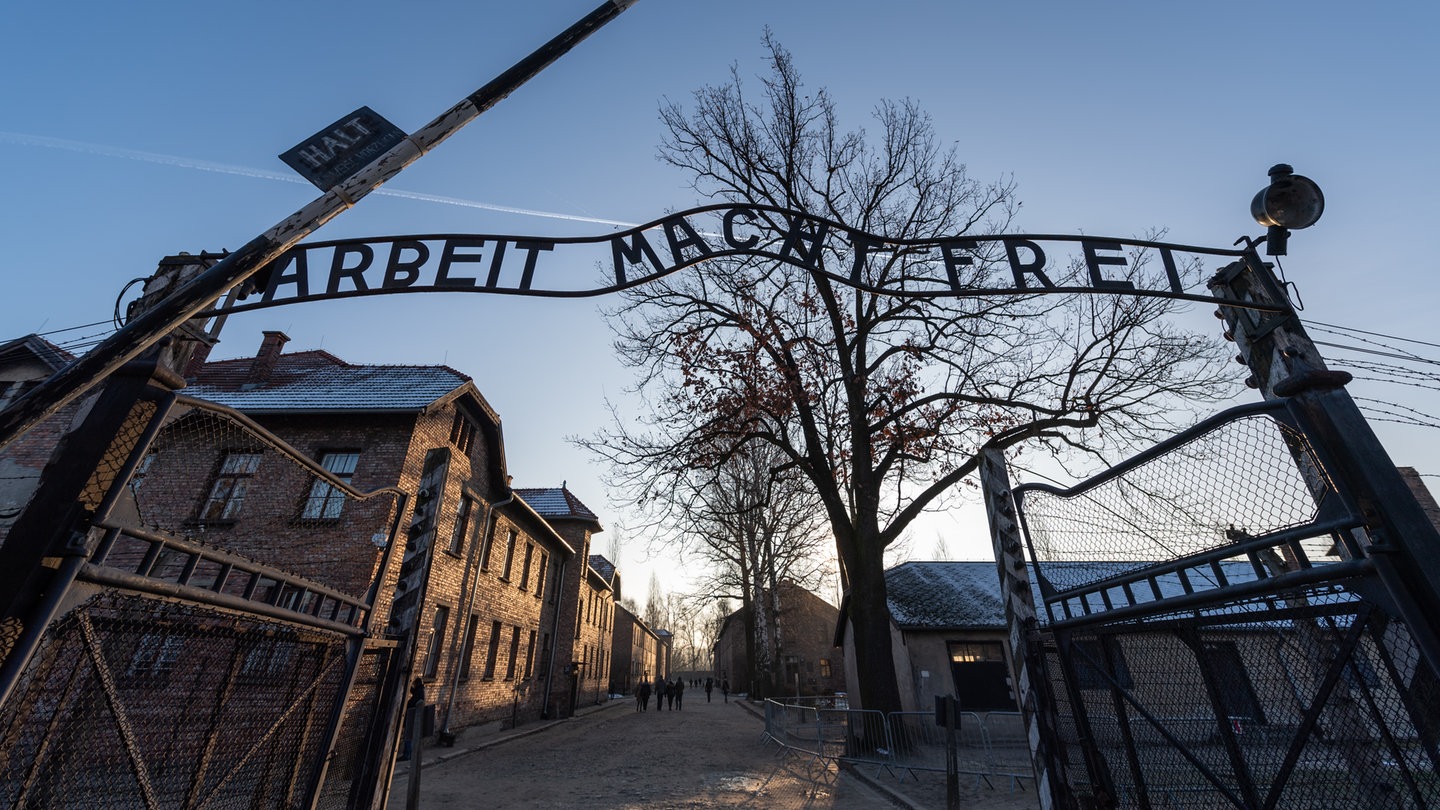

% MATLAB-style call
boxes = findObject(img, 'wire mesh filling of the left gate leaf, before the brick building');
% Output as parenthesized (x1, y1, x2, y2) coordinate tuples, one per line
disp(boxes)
(0, 399, 403, 809)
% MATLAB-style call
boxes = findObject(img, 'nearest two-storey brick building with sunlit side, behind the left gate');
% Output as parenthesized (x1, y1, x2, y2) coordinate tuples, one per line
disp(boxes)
(168, 331, 611, 734)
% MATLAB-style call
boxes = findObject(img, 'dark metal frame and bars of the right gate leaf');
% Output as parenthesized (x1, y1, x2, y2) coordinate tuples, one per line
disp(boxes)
(982, 399, 1440, 807)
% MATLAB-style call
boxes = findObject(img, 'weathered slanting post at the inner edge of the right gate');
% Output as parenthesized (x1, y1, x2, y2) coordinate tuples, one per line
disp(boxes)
(981, 447, 1074, 810)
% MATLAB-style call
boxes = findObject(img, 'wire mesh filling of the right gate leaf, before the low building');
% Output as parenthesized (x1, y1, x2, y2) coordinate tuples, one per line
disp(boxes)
(1015, 402, 1440, 809)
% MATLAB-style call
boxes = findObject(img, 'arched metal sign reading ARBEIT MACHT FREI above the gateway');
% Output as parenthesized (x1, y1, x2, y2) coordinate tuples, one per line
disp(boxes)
(216, 203, 1272, 311)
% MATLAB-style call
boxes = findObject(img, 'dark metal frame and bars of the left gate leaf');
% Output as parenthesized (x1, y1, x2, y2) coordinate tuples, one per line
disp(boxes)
(0, 357, 409, 807)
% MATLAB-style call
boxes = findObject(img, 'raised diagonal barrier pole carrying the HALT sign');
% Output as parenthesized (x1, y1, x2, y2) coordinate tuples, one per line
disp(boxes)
(0, 0, 635, 448)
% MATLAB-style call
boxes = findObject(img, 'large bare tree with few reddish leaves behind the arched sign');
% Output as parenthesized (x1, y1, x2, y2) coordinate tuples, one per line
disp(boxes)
(592, 35, 1224, 711)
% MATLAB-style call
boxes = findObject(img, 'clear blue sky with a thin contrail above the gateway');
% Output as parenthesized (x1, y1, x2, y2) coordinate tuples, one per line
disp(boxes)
(0, 0, 1440, 585)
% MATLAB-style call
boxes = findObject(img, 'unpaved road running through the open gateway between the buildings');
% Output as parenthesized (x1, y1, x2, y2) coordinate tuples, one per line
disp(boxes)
(389, 695, 1035, 810)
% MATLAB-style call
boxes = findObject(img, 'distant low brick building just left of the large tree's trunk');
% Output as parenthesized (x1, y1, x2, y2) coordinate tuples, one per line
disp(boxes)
(714, 581, 845, 695)
